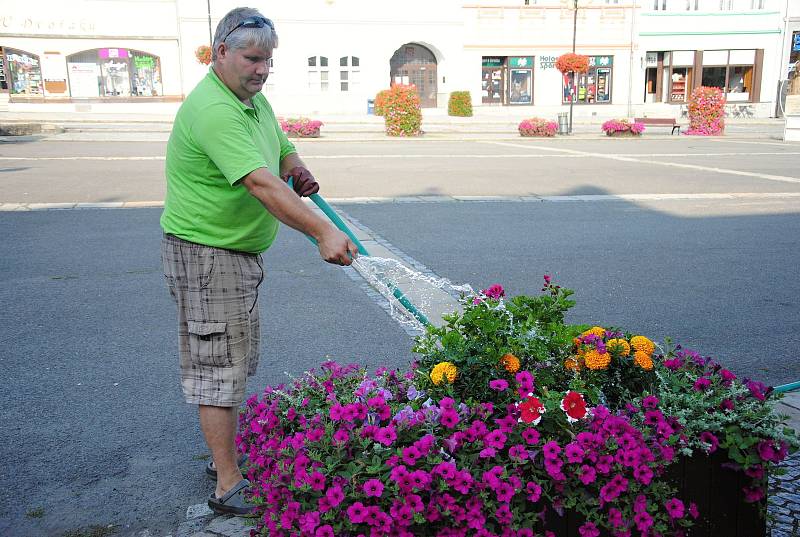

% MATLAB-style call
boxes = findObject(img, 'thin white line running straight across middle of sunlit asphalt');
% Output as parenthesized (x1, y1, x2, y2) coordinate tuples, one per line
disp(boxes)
(0, 151, 800, 162)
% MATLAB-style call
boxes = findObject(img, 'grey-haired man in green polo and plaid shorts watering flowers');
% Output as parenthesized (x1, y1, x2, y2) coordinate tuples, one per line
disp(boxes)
(161, 8, 357, 516)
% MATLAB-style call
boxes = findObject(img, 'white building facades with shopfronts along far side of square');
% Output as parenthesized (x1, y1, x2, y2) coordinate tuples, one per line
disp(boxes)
(0, 0, 800, 118)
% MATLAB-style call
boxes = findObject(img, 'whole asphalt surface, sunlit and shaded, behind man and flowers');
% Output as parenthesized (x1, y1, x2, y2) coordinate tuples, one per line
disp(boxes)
(0, 133, 800, 536)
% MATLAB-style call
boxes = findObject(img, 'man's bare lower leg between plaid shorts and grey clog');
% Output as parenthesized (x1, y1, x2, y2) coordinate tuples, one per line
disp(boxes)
(198, 405, 242, 498)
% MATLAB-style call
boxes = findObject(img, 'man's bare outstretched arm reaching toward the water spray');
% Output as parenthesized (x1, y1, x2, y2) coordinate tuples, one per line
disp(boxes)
(242, 166, 358, 265)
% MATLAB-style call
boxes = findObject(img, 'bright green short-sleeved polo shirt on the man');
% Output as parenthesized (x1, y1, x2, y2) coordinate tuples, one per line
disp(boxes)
(161, 69, 296, 254)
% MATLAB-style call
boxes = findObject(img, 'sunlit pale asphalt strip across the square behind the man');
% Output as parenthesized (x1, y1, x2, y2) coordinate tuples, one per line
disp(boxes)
(0, 135, 800, 203)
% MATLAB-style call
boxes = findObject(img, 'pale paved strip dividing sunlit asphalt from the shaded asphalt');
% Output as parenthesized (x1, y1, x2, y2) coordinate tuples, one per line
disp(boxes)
(0, 192, 800, 212)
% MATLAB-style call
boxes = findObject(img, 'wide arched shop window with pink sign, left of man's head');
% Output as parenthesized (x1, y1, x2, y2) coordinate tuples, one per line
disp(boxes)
(67, 48, 164, 97)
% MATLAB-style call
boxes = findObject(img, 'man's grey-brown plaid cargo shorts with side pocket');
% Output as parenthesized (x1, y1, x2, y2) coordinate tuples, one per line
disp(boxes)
(161, 235, 264, 407)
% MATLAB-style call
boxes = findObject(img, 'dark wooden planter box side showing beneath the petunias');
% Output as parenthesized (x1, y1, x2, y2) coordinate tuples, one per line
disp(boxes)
(542, 453, 767, 537)
